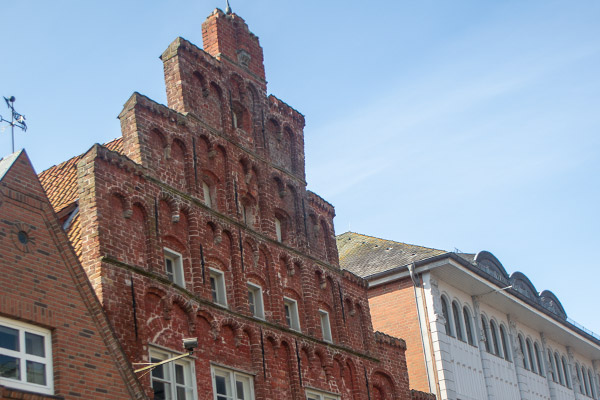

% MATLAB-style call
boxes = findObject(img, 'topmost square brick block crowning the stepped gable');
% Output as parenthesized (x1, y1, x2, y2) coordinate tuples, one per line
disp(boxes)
(202, 9, 266, 85)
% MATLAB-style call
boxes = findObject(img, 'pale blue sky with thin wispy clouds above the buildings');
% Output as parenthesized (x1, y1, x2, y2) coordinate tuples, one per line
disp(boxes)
(0, 0, 600, 333)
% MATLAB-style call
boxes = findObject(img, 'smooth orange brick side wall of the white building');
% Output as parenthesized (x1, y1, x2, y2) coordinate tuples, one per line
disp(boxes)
(369, 278, 429, 392)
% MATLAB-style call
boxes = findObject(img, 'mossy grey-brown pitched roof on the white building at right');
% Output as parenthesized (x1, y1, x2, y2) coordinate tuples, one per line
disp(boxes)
(336, 232, 447, 277)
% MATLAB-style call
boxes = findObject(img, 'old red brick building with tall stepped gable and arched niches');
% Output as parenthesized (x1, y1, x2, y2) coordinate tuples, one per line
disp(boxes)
(40, 6, 426, 400)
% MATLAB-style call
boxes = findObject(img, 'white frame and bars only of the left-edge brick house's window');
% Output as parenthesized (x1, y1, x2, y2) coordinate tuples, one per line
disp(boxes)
(0, 317, 54, 395)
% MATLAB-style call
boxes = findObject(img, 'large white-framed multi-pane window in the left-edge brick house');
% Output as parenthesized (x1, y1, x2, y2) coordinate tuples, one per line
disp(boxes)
(0, 317, 54, 394)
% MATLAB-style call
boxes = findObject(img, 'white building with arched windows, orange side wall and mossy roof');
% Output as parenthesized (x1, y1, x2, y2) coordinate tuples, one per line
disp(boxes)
(337, 232, 600, 400)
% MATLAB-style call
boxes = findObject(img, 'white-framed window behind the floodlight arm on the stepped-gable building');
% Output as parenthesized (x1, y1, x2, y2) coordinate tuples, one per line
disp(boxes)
(150, 349, 197, 400)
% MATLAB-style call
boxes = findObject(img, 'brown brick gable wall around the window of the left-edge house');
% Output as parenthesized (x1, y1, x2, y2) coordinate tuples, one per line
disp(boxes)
(0, 153, 143, 400)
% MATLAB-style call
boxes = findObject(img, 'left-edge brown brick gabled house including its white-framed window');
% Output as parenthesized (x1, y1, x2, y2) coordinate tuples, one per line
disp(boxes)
(0, 151, 146, 400)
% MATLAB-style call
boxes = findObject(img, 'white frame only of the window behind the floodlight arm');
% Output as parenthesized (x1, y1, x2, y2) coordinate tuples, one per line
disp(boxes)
(150, 347, 198, 400)
